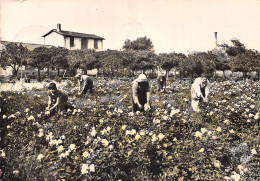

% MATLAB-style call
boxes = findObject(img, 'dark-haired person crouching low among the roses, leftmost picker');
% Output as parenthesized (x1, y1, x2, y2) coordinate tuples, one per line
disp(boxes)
(47, 83, 68, 113)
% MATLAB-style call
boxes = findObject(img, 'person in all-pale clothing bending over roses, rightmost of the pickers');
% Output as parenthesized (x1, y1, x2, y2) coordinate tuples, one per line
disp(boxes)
(191, 74, 210, 112)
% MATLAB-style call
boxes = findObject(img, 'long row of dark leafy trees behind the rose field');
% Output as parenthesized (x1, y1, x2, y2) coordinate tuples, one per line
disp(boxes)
(0, 37, 260, 80)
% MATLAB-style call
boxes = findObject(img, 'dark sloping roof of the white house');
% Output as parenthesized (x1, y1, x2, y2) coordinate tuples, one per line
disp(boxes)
(42, 29, 105, 40)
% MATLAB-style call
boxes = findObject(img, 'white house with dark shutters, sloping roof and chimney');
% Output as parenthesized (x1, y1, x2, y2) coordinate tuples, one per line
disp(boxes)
(42, 24, 105, 51)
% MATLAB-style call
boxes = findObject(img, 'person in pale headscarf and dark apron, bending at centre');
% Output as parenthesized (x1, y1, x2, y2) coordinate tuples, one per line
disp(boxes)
(132, 74, 150, 113)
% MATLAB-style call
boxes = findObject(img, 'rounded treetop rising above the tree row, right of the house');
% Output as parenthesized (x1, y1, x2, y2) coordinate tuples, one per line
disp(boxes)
(123, 36, 153, 51)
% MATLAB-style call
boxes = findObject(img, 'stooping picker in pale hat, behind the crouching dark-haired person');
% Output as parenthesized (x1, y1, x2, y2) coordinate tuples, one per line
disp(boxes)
(75, 74, 93, 95)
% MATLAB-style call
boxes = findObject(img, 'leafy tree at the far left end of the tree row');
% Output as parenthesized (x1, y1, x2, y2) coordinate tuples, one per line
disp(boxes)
(0, 43, 29, 76)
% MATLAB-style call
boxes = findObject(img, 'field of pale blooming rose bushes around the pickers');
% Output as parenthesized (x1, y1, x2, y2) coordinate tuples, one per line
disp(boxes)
(0, 78, 260, 181)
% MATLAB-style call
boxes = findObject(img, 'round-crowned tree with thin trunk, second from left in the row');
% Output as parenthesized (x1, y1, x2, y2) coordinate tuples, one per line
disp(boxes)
(28, 46, 52, 81)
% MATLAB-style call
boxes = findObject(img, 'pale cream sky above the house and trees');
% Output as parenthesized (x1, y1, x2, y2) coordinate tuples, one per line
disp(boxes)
(0, 0, 260, 54)
